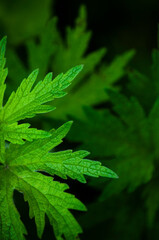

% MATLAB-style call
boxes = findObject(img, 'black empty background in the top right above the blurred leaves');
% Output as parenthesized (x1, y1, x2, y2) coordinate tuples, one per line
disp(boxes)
(54, 0, 159, 68)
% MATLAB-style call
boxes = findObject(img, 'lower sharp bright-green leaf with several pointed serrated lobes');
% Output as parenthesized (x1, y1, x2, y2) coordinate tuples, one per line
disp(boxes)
(0, 122, 117, 240)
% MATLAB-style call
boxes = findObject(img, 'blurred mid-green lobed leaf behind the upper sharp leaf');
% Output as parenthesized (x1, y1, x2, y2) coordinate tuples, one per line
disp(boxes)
(8, 6, 134, 120)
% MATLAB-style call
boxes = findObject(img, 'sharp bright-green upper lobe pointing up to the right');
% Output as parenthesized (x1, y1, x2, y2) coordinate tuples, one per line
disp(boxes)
(3, 65, 83, 123)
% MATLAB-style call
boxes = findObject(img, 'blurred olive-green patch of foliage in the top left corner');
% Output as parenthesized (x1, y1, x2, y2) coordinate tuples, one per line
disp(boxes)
(0, 0, 52, 44)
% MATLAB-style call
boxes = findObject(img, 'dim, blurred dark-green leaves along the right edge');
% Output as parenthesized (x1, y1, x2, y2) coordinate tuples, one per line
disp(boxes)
(68, 35, 159, 240)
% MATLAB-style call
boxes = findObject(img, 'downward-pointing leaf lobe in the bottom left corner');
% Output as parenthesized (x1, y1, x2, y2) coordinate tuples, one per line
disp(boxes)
(0, 166, 27, 240)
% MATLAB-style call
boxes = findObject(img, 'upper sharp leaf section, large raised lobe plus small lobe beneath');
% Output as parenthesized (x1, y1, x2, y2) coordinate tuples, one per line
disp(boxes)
(0, 65, 83, 144)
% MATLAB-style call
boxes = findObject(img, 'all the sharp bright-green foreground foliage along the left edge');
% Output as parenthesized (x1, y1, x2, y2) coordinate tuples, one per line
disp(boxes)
(0, 38, 117, 240)
